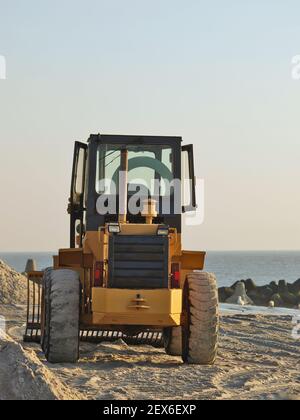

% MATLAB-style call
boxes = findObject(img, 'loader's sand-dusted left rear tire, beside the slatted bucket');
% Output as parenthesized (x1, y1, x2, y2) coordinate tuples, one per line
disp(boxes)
(41, 269, 80, 363)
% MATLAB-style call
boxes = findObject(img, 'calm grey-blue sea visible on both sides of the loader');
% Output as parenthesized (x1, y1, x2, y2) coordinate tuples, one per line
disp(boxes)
(0, 251, 300, 286)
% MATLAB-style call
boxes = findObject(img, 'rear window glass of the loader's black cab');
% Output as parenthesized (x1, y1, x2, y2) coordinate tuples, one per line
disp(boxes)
(96, 145, 174, 196)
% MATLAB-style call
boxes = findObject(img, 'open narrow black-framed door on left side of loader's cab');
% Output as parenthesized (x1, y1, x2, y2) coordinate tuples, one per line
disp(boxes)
(68, 142, 87, 248)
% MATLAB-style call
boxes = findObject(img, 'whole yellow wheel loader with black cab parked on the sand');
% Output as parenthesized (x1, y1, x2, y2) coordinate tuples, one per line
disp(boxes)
(24, 134, 219, 365)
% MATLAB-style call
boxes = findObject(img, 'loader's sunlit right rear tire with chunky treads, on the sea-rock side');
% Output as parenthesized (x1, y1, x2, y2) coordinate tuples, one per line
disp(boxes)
(182, 272, 219, 365)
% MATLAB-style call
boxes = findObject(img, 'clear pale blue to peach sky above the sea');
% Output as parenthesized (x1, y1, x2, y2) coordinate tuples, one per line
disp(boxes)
(0, 0, 300, 251)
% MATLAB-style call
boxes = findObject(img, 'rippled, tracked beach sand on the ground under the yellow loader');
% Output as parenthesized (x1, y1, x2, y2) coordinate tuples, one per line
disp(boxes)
(0, 305, 300, 400)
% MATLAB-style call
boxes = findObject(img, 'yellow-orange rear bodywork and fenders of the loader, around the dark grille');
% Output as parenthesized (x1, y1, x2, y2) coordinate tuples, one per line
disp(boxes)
(50, 230, 205, 328)
